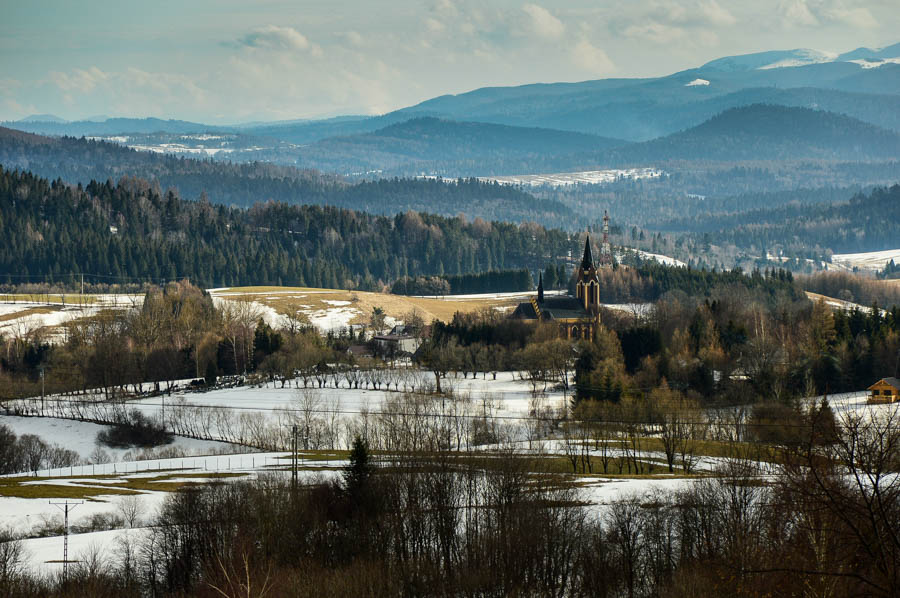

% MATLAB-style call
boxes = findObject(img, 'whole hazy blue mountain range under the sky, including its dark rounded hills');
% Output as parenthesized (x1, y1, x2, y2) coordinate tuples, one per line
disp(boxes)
(1, 44, 900, 185)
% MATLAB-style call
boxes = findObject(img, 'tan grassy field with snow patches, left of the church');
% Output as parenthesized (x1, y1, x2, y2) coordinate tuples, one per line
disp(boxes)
(214, 287, 527, 324)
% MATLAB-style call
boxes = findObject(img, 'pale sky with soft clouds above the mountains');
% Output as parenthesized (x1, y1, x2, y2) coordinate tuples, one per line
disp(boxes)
(0, 0, 900, 123)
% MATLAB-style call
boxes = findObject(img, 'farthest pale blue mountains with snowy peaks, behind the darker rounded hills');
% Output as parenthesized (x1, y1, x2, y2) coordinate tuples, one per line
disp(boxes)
(2, 44, 900, 144)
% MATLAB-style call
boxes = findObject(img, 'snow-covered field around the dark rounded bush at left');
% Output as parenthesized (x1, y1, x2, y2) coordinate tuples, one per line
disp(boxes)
(0, 415, 241, 462)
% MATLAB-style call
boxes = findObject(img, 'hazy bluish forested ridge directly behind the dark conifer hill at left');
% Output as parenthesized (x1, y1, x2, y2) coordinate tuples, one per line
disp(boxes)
(0, 128, 575, 227)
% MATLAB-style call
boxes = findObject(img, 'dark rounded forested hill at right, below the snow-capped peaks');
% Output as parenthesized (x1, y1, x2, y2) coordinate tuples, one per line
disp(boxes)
(610, 104, 900, 162)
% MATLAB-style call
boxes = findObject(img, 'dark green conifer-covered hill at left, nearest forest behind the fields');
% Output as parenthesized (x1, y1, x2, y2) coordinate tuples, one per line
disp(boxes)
(0, 169, 578, 289)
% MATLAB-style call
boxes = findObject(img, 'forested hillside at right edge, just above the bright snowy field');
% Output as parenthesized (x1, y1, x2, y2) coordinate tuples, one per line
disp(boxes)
(684, 185, 900, 253)
